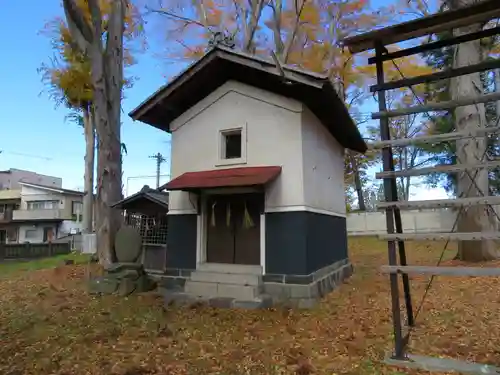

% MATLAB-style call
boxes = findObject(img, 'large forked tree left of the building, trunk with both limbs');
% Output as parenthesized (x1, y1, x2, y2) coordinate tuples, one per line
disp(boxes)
(62, 0, 139, 266)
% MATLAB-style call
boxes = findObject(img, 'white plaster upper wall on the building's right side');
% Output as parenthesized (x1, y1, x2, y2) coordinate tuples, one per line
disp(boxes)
(302, 108, 346, 216)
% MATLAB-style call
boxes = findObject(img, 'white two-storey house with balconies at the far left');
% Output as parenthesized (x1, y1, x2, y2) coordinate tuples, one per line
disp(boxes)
(0, 181, 84, 243)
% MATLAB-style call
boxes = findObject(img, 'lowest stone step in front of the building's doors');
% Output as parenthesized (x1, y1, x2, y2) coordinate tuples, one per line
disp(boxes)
(185, 280, 261, 300)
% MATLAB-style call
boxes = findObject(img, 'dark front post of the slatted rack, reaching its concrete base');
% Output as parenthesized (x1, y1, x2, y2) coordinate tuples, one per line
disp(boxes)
(376, 46, 404, 359)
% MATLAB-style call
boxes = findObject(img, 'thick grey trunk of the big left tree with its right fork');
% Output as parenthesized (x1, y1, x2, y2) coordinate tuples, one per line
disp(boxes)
(92, 0, 125, 265)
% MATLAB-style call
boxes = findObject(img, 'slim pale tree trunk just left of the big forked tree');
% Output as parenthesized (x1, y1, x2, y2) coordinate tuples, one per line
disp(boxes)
(82, 108, 95, 233)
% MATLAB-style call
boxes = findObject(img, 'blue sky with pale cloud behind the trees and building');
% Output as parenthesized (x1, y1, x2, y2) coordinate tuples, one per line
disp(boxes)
(0, 0, 446, 199)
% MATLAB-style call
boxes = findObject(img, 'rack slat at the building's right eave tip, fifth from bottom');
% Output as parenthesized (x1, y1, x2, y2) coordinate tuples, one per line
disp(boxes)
(368, 126, 500, 150)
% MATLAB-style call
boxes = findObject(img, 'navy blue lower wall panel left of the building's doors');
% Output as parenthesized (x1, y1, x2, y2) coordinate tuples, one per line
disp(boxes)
(167, 214, 198, 269)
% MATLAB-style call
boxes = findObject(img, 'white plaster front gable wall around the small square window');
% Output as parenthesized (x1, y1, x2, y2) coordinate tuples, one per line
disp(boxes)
(169, 81, 305, 214)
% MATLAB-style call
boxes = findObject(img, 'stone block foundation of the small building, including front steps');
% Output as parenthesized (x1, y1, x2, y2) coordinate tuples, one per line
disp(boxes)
(152, 259, 353, 308)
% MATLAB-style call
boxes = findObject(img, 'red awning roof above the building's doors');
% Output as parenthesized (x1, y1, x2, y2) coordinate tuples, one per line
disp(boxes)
(161, 166, 281, 190)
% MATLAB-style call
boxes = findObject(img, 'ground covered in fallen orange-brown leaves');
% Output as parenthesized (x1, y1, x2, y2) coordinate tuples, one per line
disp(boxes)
(0, 238, 500, 375)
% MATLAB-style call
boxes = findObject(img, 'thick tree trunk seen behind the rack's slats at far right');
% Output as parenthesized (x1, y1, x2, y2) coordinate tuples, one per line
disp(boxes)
(450, 0, 500, 261)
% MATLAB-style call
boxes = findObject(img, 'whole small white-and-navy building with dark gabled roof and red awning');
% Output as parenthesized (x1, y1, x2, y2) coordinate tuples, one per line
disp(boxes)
(130, 47, 367, 307)
